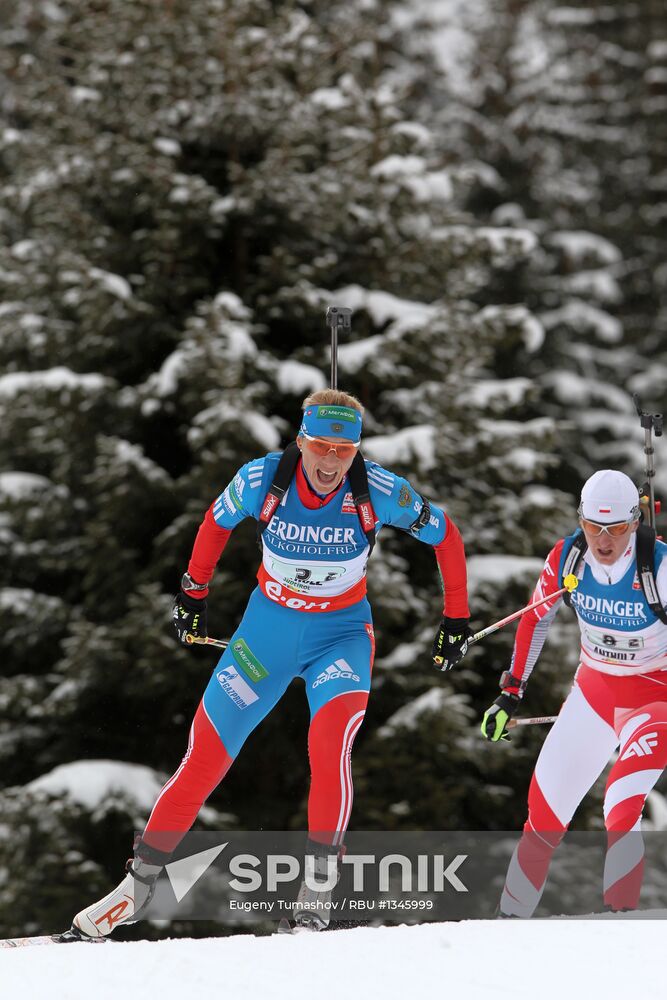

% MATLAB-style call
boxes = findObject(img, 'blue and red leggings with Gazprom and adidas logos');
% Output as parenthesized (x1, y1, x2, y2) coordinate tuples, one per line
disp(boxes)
(143, 589, 375, 851)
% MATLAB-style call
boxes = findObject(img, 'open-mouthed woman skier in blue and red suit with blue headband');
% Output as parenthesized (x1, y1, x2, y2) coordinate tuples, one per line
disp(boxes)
(74, 389, 470, 937)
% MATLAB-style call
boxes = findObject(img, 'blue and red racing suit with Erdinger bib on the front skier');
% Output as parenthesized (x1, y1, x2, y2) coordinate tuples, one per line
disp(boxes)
(144, 453, 469, 850)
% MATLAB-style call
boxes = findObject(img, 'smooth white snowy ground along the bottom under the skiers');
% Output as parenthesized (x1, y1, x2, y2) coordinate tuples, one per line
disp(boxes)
(0, 919, 665, 1000)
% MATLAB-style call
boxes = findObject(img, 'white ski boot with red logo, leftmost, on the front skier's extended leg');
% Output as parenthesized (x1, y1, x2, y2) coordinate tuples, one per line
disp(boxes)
(72, 838, 171, 938)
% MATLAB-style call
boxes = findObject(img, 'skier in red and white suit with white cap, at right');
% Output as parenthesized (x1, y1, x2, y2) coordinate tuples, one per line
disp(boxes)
(482, 469, 667, 917)
